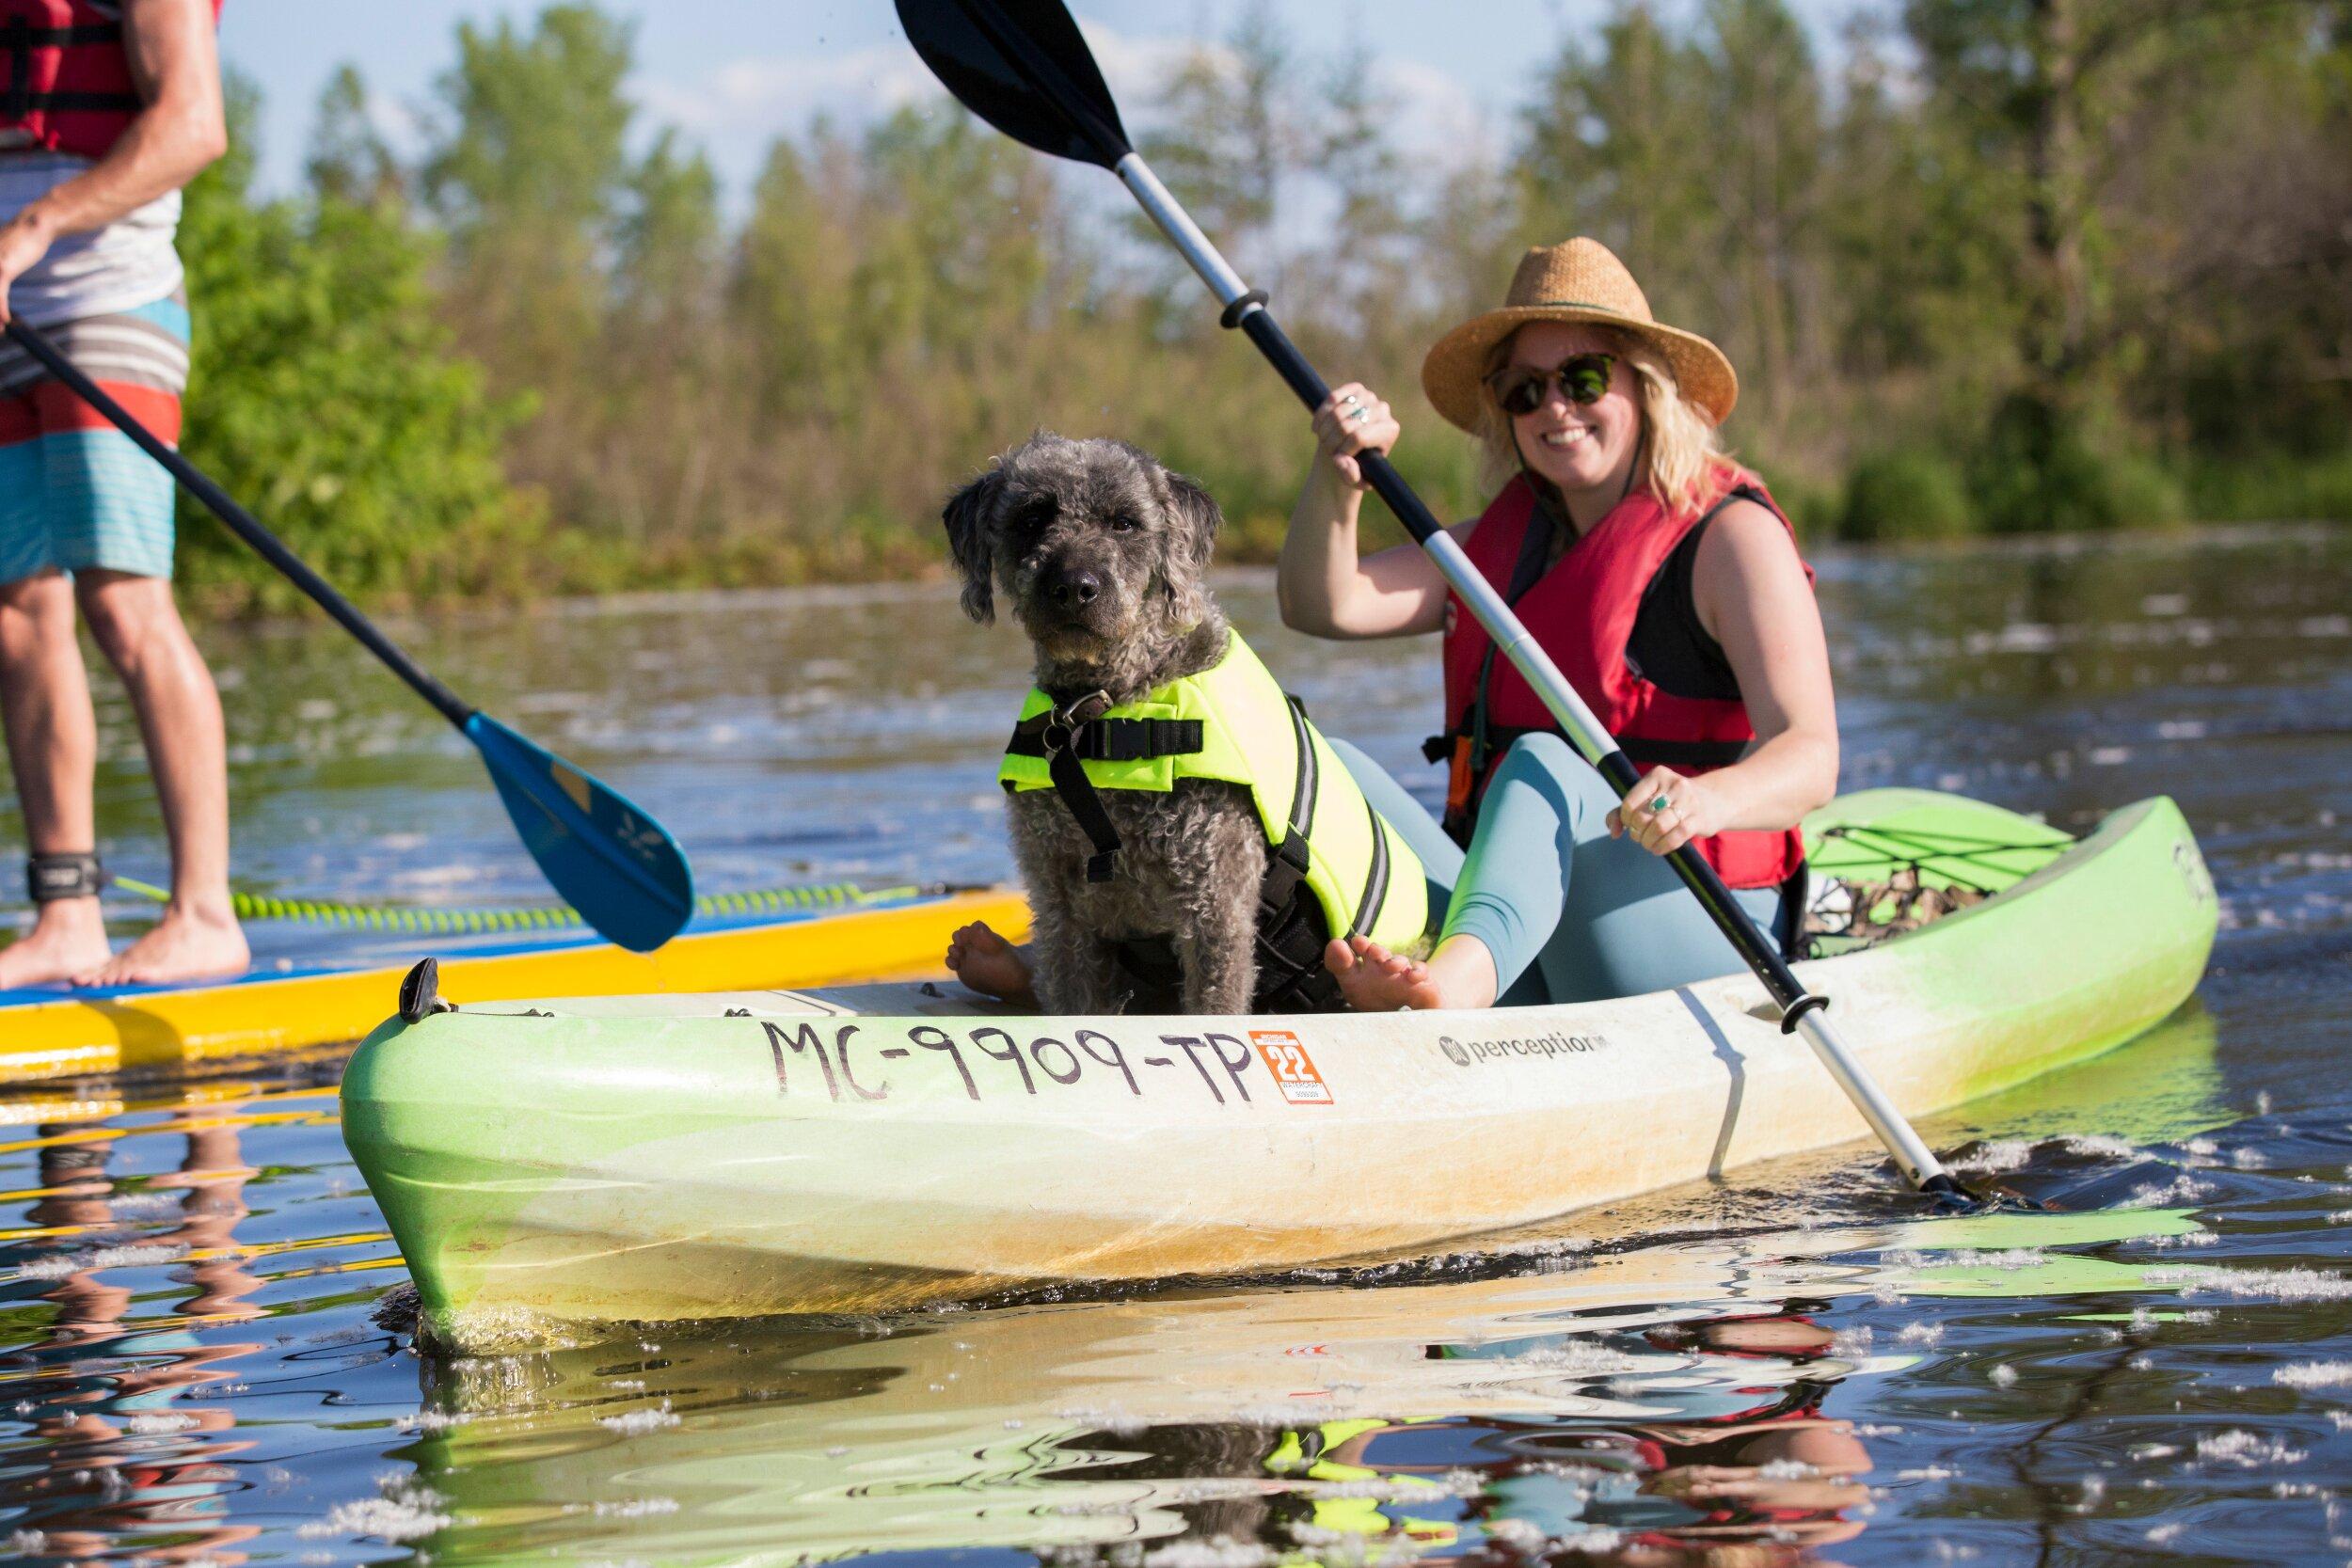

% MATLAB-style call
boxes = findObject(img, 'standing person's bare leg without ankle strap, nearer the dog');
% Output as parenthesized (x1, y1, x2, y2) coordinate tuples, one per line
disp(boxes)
(75, 569, 249, 985)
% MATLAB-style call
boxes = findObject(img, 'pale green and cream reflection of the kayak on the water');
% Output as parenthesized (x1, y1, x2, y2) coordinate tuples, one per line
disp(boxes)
(405, 1211, 2230, 1563)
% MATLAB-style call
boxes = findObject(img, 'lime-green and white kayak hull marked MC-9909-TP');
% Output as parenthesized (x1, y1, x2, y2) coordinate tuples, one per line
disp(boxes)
(343, 792, 2216, 1347)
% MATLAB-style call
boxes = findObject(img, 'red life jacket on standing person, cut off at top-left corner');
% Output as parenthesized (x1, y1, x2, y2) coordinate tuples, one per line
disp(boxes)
(0, 0, 221, 157)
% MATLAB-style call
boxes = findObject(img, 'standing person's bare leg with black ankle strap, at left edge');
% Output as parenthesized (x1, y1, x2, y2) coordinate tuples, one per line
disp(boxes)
(0, 566, 108, 990)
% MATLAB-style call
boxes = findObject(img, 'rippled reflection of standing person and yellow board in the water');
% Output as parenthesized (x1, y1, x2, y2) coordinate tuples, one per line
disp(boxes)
(0, 1082, 390, 1563)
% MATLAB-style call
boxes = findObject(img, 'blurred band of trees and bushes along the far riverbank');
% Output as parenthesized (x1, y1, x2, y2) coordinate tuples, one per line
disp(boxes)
(183, 0, 2352, 597)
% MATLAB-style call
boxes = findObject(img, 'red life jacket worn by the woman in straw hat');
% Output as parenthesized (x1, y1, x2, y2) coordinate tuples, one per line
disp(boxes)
(1433, 467, 1814, 889)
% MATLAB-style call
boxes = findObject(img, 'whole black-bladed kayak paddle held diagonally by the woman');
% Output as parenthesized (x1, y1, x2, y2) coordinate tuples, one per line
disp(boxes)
(897, 0, 1976, 1201)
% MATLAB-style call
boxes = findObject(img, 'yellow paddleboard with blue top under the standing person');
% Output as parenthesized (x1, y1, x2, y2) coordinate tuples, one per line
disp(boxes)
(0, 889, 1028, 1084)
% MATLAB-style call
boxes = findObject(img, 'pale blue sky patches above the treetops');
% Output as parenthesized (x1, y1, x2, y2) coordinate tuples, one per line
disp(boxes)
(221, 0, 1872, 193)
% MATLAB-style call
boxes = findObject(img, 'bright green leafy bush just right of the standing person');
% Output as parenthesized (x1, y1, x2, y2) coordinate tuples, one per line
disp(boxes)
(179, 78, 534, 602)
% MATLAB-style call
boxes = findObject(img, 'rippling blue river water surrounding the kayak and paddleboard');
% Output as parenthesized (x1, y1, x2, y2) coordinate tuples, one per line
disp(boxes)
(0, 533, 2352, 1568)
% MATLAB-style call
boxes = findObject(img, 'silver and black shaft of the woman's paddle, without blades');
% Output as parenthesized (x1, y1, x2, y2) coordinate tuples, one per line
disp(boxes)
(1113, 152, 1960, 1195)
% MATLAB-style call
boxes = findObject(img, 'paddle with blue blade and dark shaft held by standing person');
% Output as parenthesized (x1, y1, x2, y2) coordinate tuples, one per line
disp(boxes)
(8, 320, 694, 952)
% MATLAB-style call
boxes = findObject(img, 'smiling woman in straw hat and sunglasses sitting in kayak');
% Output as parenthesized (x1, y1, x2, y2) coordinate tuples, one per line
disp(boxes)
(1279, 240, 1837, 1011)
